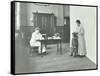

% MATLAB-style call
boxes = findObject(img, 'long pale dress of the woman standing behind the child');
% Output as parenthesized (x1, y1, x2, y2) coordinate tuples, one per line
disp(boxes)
(77, 26, 86, 55)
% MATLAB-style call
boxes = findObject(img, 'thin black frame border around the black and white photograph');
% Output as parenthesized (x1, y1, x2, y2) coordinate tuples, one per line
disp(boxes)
(11, 1, 98, 75)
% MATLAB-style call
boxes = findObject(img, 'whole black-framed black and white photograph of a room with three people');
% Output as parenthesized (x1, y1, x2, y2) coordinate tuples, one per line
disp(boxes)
(11, 1, 98, 74)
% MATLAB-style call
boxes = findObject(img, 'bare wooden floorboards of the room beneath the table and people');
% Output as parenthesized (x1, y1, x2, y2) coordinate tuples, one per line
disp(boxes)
(15, 36, 96, 73)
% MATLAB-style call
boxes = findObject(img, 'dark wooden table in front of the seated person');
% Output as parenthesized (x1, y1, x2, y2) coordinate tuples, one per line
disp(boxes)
(38, 39, 62, 56)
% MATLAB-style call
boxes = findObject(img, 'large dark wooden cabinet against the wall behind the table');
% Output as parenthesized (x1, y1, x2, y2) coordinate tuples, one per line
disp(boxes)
(33, 13, 56, 36)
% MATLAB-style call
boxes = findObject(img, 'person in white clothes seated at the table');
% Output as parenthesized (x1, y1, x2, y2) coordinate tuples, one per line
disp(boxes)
(30, 27, 46, 54)
